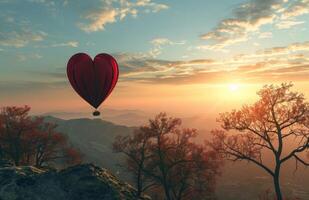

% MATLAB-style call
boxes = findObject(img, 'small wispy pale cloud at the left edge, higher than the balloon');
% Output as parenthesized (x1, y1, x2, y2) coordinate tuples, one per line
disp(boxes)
(0, 30, 47, 48)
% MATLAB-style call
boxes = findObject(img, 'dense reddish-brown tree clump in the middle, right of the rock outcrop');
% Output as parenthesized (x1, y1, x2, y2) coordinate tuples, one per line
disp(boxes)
(114, 113, 221, 200)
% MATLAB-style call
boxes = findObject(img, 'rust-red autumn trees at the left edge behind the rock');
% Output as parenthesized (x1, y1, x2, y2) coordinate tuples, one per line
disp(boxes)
(0, 106, 81, 167)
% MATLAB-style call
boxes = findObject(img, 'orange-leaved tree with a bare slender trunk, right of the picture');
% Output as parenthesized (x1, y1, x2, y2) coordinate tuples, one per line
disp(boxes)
(211, 83, 309, 200)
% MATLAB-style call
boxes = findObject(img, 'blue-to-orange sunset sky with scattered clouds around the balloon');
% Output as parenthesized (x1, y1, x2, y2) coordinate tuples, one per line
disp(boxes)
(0, 0, 309, 118)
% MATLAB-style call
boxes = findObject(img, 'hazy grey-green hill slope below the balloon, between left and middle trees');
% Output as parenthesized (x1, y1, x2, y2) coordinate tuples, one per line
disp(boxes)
(45, 116, 135, 179)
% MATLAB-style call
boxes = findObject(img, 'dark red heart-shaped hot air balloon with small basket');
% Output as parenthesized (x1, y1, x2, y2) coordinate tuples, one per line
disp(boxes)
(67, 53, 119, 116)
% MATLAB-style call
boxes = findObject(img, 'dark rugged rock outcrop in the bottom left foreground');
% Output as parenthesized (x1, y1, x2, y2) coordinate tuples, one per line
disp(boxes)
(0, 164, 150, 200)
